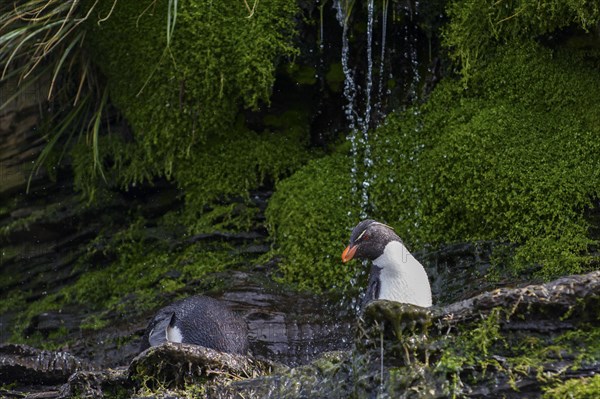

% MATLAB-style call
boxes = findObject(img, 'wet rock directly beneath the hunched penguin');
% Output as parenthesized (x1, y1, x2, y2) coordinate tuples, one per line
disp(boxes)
(129, 342, 273, 388)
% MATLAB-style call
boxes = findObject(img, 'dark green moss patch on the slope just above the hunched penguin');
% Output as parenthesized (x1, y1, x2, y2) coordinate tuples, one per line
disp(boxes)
(66, 225, 234, 318)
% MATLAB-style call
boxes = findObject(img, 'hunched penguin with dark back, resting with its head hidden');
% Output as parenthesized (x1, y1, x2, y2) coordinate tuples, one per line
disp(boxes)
(140, 296, 248, 355)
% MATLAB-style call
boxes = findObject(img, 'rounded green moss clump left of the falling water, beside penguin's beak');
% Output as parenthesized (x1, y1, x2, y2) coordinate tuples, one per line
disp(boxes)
(266, 154, 356, 291)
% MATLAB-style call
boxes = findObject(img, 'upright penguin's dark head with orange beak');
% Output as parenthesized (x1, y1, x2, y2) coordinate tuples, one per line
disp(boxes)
(342, 219, 402, 263)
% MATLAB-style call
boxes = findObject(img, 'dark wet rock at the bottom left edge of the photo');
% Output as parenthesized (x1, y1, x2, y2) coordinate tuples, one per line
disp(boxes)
(0, 344, 91, 385)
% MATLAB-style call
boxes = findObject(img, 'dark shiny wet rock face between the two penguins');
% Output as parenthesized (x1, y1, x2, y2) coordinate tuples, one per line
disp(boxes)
(216, 270, 354, 366)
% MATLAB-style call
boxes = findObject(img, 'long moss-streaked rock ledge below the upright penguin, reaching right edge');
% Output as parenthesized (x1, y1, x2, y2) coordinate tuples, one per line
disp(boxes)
(215, 271, 600, 398)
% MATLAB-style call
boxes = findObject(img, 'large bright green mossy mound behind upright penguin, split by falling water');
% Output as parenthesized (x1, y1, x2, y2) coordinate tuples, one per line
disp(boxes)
(268, 44, 600, 288)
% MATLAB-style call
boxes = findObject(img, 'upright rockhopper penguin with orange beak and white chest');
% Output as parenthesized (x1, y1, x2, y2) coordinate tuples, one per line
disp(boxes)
(342, 219, 431, 308)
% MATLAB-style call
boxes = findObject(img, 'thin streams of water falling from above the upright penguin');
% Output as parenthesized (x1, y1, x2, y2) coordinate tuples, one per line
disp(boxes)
(334, 0, 421, 225)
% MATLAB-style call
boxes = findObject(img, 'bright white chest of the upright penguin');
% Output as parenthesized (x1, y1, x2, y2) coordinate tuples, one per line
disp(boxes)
(373, 241, 432, 307)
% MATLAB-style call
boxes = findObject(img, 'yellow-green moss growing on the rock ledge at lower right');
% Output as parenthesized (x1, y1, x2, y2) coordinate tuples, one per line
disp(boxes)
(432, 309, 600, 397)
